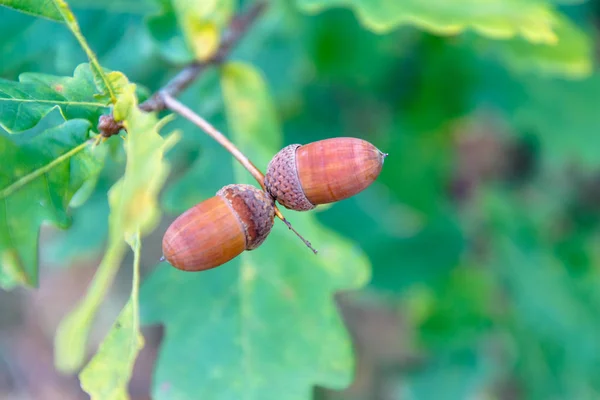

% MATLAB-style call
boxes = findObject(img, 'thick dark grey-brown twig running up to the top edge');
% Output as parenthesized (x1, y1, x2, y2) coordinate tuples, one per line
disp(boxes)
(140, 2, 266, 111)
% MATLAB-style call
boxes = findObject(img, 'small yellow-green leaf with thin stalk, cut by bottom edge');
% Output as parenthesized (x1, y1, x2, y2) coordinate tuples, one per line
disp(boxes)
(79, 233, 144, 400)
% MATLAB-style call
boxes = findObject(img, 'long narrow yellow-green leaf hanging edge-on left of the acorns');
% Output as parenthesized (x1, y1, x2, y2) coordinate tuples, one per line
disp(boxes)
(54, 77, 178, 372)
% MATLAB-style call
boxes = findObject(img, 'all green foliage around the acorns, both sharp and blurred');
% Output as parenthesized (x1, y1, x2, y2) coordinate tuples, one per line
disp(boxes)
(0, 0, 600, 400)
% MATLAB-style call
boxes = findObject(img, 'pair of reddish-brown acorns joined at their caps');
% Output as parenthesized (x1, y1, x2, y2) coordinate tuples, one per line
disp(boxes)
(162, 138, 386, 271)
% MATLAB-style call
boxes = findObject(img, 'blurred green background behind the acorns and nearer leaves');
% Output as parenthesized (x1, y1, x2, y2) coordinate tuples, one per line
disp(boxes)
(0, 0, 600, 400)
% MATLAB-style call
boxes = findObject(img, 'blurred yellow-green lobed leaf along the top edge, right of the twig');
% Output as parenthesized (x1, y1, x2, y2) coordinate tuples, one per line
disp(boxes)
(296, 0, 568, 43)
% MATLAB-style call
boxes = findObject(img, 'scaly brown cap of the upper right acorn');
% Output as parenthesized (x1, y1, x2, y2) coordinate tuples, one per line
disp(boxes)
(265, 144, 315, 211)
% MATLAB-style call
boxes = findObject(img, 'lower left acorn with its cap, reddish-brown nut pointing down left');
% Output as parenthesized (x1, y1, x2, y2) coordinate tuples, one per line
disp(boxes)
(162, 184, 275, 271)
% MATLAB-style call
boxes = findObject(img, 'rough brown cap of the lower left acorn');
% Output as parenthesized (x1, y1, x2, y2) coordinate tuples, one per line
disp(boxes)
(217, 184, 275, 250)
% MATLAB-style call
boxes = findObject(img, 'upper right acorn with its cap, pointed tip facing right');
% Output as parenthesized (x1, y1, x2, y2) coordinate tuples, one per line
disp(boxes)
(265, 137, 387, 211)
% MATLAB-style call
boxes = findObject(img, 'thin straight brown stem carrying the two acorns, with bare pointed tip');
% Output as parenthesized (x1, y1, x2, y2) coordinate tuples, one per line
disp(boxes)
(158, 92, 317, 254)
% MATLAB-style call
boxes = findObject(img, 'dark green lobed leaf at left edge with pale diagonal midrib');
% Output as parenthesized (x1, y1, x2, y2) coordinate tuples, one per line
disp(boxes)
(0, 115, 105, 287)
